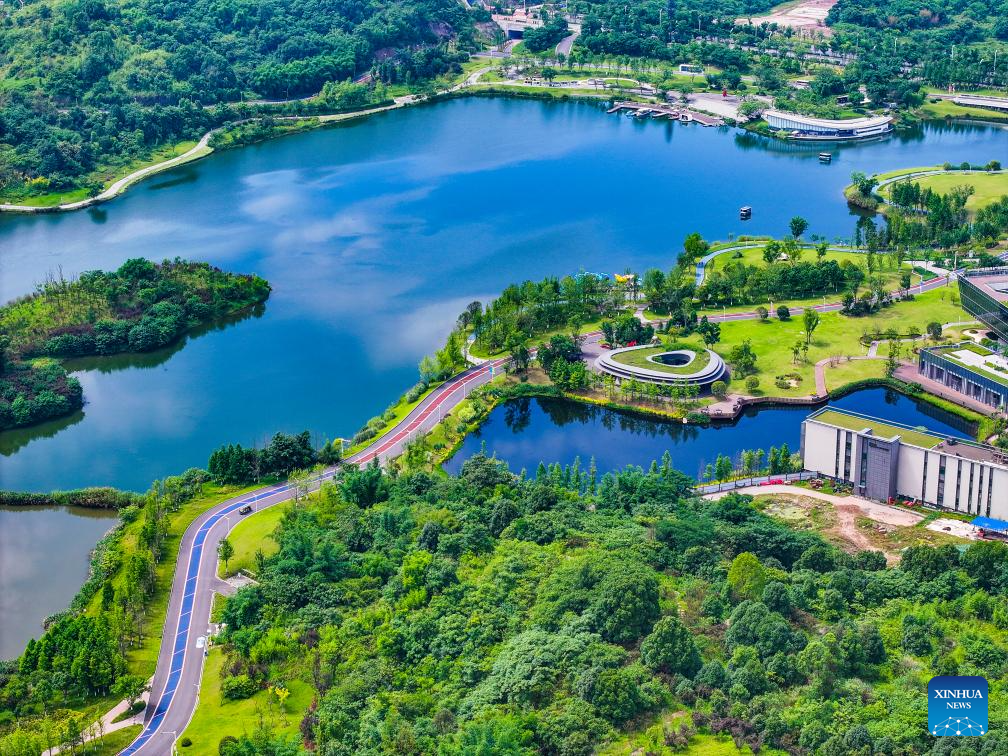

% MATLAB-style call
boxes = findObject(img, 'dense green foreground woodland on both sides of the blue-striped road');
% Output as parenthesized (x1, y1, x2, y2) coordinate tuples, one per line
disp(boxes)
(0, 455, 1008, 756)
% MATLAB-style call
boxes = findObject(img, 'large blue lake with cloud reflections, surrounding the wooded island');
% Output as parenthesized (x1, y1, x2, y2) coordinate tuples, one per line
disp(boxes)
(0, 98, 1008, 491)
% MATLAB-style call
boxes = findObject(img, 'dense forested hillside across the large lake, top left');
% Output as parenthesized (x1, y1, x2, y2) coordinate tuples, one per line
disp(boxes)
(0, 0, 474, 198)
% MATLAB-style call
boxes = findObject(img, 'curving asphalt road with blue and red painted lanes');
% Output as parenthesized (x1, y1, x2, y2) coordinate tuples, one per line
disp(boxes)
(121, 360, 506, 756)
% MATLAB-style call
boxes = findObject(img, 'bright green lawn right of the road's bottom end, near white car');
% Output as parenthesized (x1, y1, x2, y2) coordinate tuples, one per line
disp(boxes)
(178, 648, 314, 756)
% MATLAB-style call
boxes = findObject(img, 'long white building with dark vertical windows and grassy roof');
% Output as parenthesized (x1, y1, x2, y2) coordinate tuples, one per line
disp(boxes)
(801, 407, 1008, 520)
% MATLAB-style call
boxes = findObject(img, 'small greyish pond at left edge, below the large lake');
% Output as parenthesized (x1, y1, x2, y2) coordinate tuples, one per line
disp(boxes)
(0, 507, 118, 659)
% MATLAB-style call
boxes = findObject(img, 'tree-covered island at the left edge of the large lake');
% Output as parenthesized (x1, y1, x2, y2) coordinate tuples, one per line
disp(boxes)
(0, 258, 270, 430)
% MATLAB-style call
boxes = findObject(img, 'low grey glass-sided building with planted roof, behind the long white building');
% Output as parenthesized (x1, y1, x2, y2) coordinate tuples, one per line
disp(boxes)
(917, 342, 1008, 409)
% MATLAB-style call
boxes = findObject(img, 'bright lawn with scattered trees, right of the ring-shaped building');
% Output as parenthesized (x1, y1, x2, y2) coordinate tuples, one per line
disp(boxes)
(715, 287, 969, 396)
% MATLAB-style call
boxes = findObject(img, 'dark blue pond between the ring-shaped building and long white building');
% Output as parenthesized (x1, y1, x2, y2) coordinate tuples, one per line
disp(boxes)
(445, 388, 974, 480)
